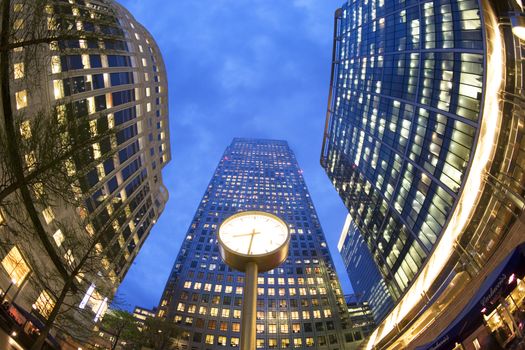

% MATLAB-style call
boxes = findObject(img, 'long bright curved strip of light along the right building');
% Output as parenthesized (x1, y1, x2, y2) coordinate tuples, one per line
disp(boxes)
(366, 4, 504, 349)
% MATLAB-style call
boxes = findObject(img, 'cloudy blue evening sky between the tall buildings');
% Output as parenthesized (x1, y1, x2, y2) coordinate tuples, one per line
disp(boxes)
(114, 0, 351, 308)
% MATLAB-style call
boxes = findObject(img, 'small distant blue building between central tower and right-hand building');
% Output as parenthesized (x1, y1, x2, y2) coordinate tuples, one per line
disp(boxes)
(337, 216, 394, 325)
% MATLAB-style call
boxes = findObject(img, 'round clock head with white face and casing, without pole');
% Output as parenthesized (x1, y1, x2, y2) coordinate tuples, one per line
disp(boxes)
(218, 211, 290, 272)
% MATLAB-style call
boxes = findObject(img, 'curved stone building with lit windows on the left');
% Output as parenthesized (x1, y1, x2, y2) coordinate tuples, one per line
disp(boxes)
(0, 0, 171, 342)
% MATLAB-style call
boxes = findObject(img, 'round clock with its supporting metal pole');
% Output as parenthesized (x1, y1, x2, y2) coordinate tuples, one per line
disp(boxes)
(218, 211, 290, 350)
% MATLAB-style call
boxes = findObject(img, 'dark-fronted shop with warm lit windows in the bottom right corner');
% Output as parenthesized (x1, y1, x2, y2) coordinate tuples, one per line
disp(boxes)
(417, 244, 525, 350)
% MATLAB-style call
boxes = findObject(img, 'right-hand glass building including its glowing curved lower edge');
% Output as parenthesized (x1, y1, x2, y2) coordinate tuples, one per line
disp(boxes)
(321, 0, 524, 348)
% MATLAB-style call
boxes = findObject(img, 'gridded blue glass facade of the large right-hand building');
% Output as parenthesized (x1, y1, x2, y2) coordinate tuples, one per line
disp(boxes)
(321, 0, 485, 299)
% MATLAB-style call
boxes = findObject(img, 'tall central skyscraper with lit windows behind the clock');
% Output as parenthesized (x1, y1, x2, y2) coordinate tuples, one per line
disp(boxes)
(158, 138, 362, 349)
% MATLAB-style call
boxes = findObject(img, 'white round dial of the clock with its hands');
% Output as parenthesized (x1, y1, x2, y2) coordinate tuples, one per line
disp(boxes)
(219, 211, 288, 256)
